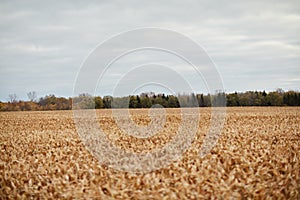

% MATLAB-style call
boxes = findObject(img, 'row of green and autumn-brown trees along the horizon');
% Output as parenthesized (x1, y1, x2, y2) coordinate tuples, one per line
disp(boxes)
(0, 89, 300, 111)
